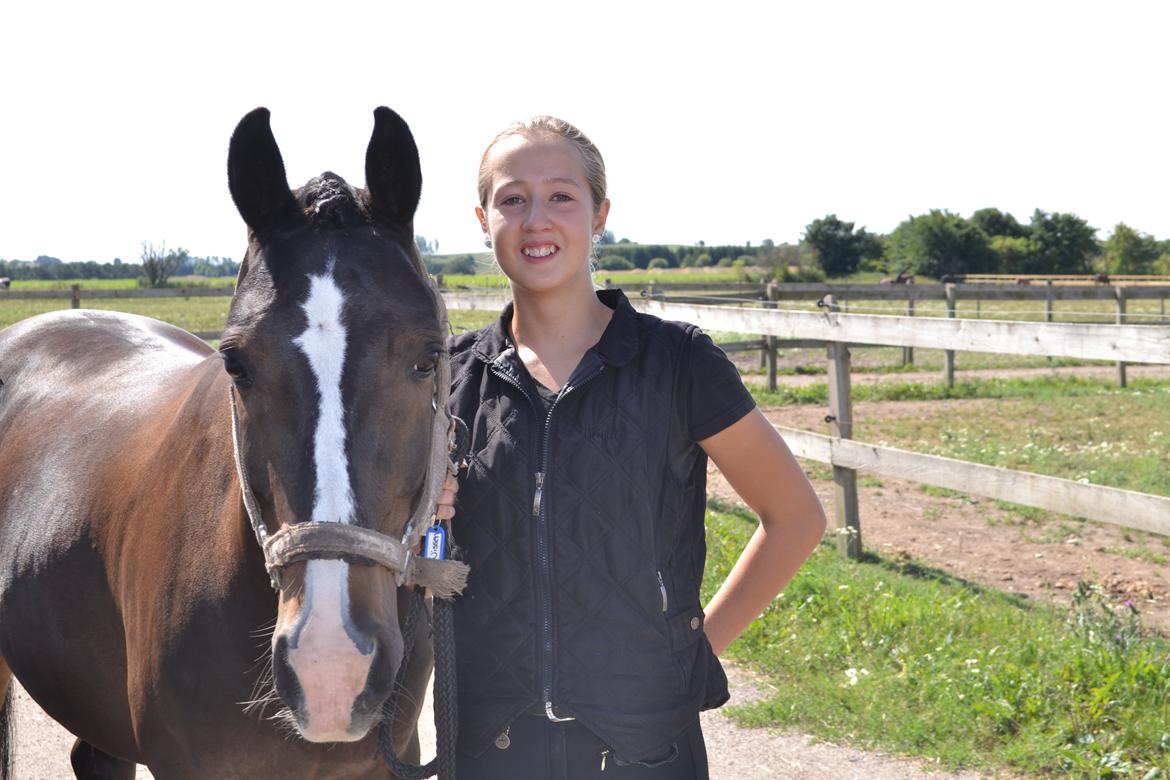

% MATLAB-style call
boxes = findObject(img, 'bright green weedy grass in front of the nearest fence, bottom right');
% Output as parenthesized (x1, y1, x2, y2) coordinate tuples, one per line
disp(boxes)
(704, 504, 1170, 778)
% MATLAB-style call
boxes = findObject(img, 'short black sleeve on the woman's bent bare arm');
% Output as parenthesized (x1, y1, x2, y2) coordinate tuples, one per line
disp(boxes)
(683, 327, 756, 442)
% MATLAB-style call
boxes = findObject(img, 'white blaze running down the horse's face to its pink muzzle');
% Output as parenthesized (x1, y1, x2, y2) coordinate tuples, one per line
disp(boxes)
(288, 272, 372, 741)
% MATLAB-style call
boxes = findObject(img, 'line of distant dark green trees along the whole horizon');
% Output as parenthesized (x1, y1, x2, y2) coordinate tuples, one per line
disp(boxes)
(0, 208, 1170, 287)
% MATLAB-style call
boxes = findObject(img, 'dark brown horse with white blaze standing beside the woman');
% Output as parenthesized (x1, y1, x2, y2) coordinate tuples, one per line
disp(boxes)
(0, 108, 466, 780)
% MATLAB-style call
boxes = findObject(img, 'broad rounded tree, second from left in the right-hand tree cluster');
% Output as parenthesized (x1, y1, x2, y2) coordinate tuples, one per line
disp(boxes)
(887, 209, 997, 278)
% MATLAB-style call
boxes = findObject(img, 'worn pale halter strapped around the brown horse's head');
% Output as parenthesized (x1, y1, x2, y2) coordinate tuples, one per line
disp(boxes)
(228, 270, 468, 599)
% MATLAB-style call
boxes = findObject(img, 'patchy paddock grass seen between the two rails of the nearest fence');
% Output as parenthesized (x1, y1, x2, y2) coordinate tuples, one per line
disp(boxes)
(751, 377, 1170, 500)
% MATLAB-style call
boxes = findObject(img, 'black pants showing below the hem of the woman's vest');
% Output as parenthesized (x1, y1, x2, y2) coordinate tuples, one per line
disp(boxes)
(456, 715, 708, 780)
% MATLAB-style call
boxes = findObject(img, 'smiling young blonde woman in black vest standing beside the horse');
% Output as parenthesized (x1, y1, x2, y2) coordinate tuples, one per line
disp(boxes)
(437, 117, 825, 780)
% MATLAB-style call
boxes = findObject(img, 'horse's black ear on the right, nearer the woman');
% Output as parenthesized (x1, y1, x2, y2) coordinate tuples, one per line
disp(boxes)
(366, 106, 422, 228)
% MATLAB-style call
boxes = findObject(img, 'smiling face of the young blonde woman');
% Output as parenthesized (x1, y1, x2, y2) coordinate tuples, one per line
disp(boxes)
(475, 134, 610, 292)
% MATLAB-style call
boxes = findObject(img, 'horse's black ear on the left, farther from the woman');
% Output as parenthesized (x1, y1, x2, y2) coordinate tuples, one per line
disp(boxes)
(227, 108, 296, 230)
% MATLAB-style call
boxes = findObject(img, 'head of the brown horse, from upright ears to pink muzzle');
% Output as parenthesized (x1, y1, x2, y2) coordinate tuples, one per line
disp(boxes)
(220, 108, 445, 741)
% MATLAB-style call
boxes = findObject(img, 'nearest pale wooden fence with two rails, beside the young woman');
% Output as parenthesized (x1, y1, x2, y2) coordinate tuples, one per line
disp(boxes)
(445, 292, 1170, 557)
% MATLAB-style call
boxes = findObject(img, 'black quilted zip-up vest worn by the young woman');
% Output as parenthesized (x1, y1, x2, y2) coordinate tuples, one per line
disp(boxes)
(450, 291, 728, 761)
